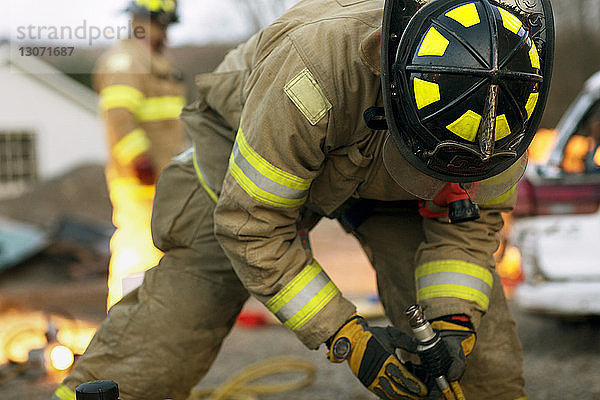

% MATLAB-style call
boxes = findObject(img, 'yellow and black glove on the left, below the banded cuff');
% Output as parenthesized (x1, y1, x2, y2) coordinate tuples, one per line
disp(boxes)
(327, 315, 427, 400)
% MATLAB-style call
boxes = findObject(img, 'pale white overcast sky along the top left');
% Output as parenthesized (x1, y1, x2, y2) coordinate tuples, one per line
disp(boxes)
(0, 0, 293, 46)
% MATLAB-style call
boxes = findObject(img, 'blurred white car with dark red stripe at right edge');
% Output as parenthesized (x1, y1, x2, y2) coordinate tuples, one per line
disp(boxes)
(510, 72, 600, 317)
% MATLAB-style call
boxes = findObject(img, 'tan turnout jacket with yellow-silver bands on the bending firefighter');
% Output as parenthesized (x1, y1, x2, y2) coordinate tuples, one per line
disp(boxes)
(183, 0, 513, 348)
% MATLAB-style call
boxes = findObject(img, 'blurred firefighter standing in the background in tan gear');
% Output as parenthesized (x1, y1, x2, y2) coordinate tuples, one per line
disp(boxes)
(94, 0, 186, 308)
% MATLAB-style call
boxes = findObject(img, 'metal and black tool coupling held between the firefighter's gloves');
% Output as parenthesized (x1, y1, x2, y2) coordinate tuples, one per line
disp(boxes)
(406, 304, 466, 400)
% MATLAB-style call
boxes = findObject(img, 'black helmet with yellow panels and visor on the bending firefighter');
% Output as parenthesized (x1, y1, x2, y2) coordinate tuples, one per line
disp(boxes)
(382, 0, 554, 201)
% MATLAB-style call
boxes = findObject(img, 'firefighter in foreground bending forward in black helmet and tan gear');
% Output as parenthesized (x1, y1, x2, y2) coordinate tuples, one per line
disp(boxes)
(55, 0, 553, 400)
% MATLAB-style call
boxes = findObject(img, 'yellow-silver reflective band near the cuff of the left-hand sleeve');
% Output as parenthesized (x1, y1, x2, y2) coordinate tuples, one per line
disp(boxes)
(265, 261, 339, 331)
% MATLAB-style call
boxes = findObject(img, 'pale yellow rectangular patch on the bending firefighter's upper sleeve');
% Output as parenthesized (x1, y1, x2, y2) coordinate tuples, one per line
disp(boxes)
(283, 68, 332, 125)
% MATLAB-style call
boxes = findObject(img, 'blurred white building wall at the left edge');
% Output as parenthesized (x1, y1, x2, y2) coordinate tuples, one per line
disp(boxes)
(0, 64, 107, 180)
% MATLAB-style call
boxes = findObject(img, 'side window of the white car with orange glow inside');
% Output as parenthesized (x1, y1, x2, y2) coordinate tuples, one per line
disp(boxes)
(561, 102, 600, 174)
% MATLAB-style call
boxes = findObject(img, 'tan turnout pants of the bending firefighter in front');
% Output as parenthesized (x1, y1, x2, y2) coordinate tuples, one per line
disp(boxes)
(59, 154, 524, 400)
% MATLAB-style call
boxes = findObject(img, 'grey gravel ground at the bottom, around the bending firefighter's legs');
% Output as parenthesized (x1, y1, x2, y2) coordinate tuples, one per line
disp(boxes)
(0, 311, 600, 400)
